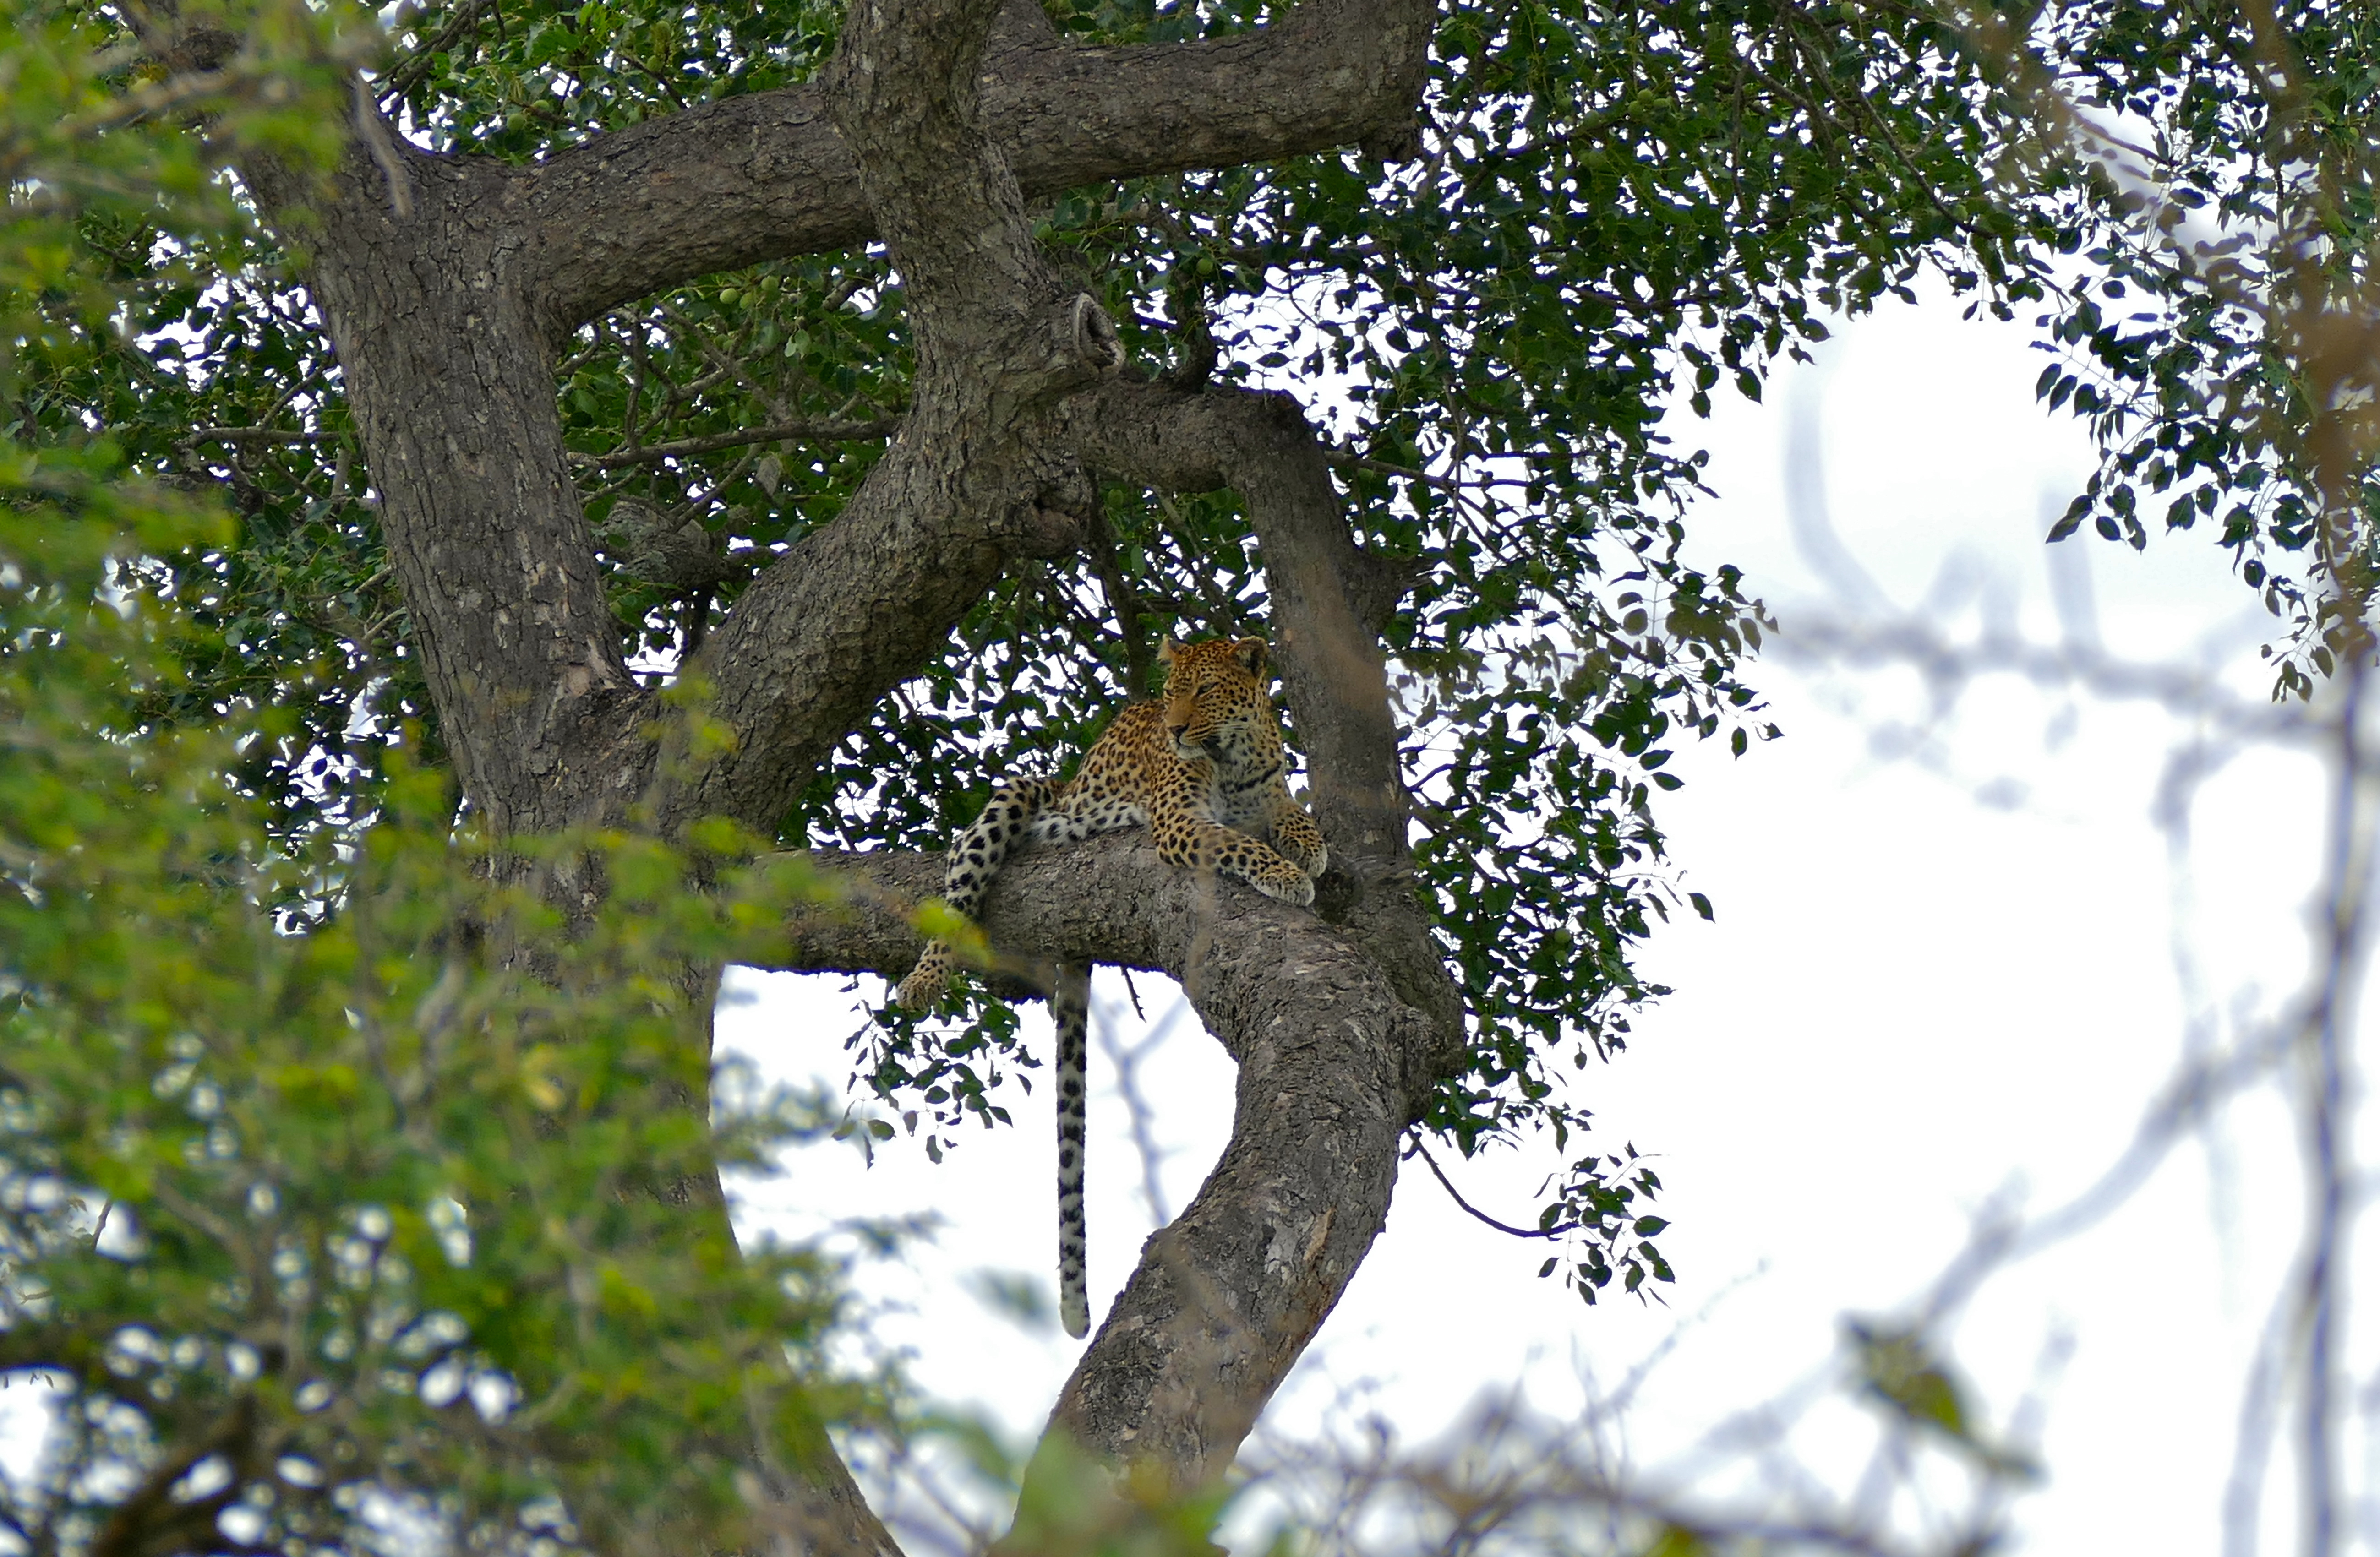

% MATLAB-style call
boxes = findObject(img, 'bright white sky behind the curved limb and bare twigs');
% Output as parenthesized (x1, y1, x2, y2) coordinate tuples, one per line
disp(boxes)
(719, 287, 2361, 1557)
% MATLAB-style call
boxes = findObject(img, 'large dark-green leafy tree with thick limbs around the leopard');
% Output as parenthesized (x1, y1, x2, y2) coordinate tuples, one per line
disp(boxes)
(12, 0, 2380, 1550)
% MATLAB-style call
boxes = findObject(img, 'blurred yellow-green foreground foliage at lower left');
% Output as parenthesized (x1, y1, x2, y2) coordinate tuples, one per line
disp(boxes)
(0, 436, 883, 1555)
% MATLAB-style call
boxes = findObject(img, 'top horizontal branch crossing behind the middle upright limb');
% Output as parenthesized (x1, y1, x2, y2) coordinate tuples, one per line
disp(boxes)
(517, 0, 1433, 338)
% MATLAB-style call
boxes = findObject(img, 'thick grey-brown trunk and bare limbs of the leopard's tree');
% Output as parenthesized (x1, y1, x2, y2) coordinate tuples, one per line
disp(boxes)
(224, 0, 1461, 1552)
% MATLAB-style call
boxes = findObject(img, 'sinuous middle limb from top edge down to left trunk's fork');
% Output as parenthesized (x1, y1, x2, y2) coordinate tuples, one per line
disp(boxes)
(655, 0, 1121, 828)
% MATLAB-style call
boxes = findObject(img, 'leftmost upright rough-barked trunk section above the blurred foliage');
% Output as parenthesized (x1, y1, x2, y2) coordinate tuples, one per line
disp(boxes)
(247, 143, 650, 833)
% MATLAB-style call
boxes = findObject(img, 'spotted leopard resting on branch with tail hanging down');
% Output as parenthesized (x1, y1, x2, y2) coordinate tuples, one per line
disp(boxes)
(893, 636, 1331, 1340)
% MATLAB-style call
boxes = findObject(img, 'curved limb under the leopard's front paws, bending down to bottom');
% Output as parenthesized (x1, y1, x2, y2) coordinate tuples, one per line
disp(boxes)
(783, 833, 1437, 1505)
